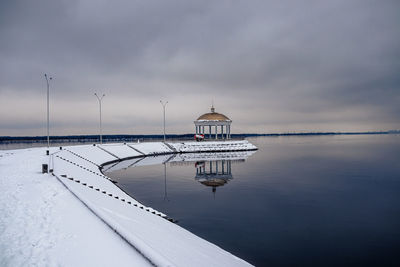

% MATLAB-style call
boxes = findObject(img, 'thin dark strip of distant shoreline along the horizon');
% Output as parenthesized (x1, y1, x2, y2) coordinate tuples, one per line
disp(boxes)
(0, 130, 400, 143)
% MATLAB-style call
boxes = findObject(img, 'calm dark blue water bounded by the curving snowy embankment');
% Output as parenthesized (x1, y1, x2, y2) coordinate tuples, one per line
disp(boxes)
(108, 135, 400, 266)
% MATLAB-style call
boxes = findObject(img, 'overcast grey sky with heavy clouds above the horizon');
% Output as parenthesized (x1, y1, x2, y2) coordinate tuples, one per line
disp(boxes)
(0, 0, 400, 136)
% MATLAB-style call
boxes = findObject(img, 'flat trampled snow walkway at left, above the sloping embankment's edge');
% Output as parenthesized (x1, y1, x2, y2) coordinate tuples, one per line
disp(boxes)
(0, 148, 151, 266)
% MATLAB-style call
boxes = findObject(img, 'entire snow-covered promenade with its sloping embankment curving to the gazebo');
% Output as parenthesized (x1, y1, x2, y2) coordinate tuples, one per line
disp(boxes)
(0, 141, 256, 266)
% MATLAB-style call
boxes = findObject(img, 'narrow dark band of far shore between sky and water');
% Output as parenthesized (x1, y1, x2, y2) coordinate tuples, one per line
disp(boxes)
(0, 130, 400, 142)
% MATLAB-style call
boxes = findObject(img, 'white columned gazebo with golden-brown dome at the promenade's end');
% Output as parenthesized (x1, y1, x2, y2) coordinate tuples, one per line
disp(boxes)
(194, 106, 232, 139)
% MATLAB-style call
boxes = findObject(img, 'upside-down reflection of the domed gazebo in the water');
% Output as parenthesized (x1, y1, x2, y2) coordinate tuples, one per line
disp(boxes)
(195, 160, 233, 196)
